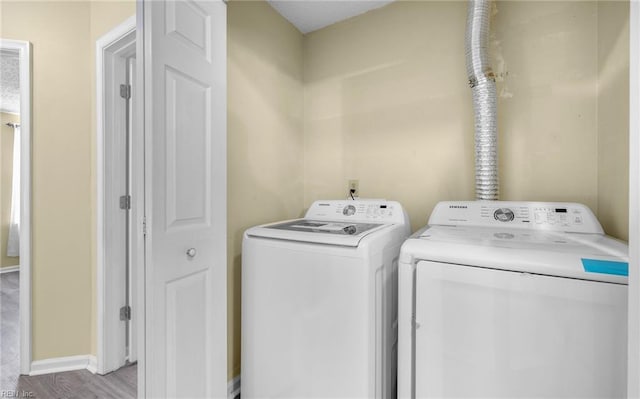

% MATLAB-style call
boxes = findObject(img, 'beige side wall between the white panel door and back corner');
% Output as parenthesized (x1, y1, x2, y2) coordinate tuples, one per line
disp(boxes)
(227, 1, 303, 378)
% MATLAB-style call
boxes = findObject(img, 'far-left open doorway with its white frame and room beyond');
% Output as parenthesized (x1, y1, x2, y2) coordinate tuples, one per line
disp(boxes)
(0, 39, 31, 382)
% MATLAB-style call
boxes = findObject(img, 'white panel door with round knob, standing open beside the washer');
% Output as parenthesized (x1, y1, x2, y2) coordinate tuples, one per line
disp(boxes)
(139, 0, 227, 398)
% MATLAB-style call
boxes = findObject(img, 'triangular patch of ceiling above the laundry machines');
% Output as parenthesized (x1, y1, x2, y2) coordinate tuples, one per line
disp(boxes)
(267, 0, 393, 33)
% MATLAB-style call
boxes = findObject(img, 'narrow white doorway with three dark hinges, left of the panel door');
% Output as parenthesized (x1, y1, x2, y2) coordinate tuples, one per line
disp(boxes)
(96, 17, 142, 374)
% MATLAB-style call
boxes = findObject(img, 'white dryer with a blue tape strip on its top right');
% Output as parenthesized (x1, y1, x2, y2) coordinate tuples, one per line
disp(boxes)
(398, 201, 628, 398)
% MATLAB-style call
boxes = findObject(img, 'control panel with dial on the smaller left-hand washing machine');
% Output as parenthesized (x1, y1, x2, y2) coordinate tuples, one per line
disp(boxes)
(304, 199, 408, 224)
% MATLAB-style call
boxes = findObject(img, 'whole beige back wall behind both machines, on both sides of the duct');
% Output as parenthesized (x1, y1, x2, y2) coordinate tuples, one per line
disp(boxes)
(304, 1, 626, 235)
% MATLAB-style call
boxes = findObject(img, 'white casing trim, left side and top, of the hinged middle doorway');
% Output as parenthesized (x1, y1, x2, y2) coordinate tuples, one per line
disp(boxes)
(95, 15, 136, 374)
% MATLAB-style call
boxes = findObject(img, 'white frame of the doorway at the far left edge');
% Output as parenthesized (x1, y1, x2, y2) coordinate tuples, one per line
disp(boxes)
(0, 39, 31, 375)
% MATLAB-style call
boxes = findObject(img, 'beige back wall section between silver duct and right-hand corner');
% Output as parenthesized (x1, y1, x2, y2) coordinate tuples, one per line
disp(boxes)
(493, 1, 598, 212)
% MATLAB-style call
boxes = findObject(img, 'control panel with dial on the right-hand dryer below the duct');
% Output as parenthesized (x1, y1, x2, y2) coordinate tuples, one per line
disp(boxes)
(429, 201, 604, 234)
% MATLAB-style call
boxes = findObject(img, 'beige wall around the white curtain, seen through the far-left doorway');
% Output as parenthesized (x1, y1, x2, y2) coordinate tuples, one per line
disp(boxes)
(0, 112, 20, 268)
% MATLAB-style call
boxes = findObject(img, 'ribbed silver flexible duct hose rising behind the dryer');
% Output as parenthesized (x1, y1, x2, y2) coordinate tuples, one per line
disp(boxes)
(465, 0, 498, 200)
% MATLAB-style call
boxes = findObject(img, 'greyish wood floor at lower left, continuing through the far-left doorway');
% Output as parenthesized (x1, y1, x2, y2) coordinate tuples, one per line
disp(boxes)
(0, 272, 137, 399)
